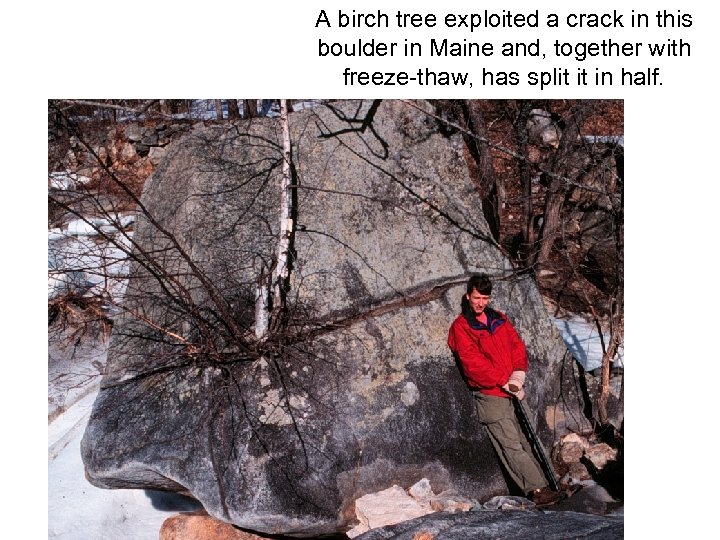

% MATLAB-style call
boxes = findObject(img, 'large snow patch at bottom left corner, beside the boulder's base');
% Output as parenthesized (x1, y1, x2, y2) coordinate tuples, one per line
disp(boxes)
(48, 326, 200, 540)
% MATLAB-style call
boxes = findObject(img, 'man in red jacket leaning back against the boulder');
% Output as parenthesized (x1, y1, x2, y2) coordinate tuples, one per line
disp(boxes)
(448, 274, 567, 506)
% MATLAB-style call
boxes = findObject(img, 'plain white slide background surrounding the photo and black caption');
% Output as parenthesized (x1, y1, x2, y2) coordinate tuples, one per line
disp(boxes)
(0, 0, 720, 537)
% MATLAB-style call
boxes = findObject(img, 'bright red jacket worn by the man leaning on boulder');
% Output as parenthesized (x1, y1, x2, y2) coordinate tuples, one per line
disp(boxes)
(448, 308, 528, 397)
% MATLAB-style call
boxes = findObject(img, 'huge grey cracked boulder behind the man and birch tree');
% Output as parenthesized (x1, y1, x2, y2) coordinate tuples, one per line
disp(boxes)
(82, 101, 569, 536)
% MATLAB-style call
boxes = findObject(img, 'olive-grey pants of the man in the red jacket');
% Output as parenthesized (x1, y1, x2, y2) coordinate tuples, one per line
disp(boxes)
(473, 392, 548, 494)
